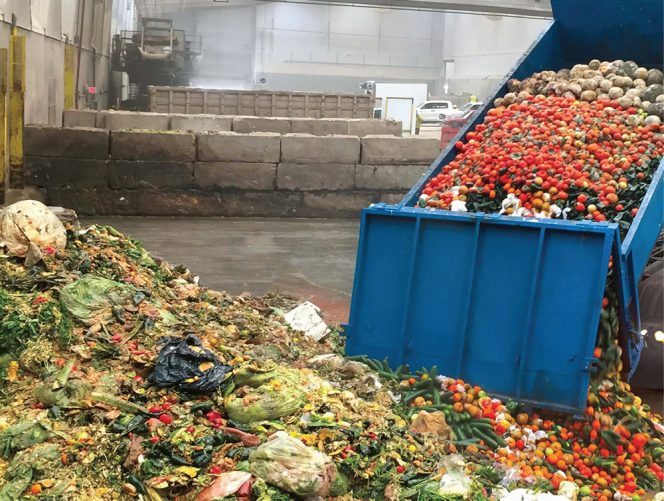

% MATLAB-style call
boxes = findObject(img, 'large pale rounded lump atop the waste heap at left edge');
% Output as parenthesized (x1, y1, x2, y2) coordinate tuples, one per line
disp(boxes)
(0, 200, 67, 264)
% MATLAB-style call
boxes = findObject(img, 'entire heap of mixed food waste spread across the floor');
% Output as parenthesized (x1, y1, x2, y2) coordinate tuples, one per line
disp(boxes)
(0, 202, 664, 501)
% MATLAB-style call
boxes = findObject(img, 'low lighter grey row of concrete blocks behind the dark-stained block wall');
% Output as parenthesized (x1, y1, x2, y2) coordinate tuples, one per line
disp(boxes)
(63, 110, 401, 137)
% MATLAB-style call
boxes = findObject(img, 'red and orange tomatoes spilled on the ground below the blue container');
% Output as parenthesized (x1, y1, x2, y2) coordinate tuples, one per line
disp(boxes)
(443, 380, 664, 501)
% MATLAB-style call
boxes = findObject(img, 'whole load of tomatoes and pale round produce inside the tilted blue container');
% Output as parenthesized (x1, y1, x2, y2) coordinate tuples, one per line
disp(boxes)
(418, 61, 664, 232)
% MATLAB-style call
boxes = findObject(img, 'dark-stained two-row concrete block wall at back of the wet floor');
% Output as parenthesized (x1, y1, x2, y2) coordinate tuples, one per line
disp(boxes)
(25, 126, 439, 217)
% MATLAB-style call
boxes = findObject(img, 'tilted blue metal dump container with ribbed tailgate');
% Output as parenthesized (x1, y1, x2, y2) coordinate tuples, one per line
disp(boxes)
(346, 0, 664, 412)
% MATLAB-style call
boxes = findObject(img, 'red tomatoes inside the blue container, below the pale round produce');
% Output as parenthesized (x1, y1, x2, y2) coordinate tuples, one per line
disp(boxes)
(420, 96, 664, 229)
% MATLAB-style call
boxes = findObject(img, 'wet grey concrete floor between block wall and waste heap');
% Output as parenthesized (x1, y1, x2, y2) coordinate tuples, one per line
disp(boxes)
(87, 217, 359, 322)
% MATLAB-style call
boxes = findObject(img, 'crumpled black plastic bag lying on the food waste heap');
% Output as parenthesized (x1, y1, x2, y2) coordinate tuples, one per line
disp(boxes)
(148, 334, 231, 393)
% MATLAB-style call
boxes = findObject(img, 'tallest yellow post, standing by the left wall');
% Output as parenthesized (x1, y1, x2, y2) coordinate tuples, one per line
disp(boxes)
(8, 27, 25, 188)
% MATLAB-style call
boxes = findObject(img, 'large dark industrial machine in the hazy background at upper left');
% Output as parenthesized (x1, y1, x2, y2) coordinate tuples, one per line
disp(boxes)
(111, 18, 201, 110)
